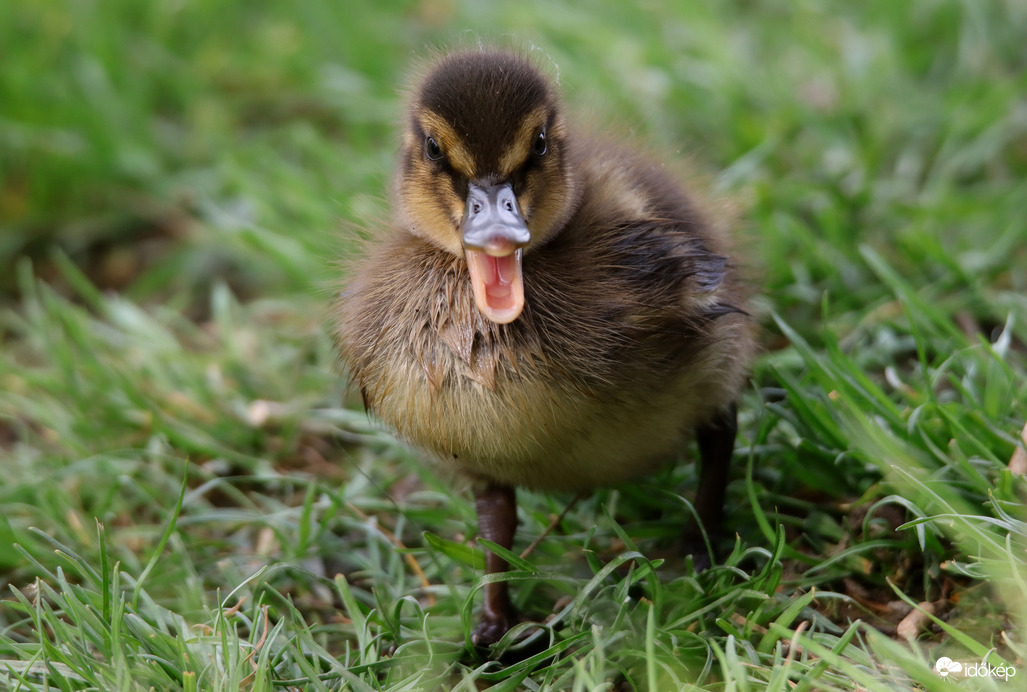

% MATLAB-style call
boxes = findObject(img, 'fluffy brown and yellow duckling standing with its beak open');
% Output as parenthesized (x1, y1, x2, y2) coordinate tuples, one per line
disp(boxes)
(335, 48, 754, 645)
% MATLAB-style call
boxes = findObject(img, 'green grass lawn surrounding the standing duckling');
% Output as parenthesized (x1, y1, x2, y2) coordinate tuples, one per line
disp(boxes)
(0, 0, 1027, 692)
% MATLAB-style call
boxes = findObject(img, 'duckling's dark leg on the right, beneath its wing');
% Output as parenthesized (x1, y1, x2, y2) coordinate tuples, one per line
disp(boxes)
(685, 403, 738, 569)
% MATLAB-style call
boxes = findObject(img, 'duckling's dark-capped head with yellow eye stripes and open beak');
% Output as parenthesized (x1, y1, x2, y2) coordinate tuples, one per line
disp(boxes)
(396, 50, 576, 323)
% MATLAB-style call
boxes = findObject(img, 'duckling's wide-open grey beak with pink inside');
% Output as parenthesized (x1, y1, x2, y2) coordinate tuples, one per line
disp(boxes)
(462, 183, 531, 324)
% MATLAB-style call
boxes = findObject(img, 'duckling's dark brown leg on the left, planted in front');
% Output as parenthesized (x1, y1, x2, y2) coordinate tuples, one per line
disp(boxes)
(471, 484, 517, 646)
